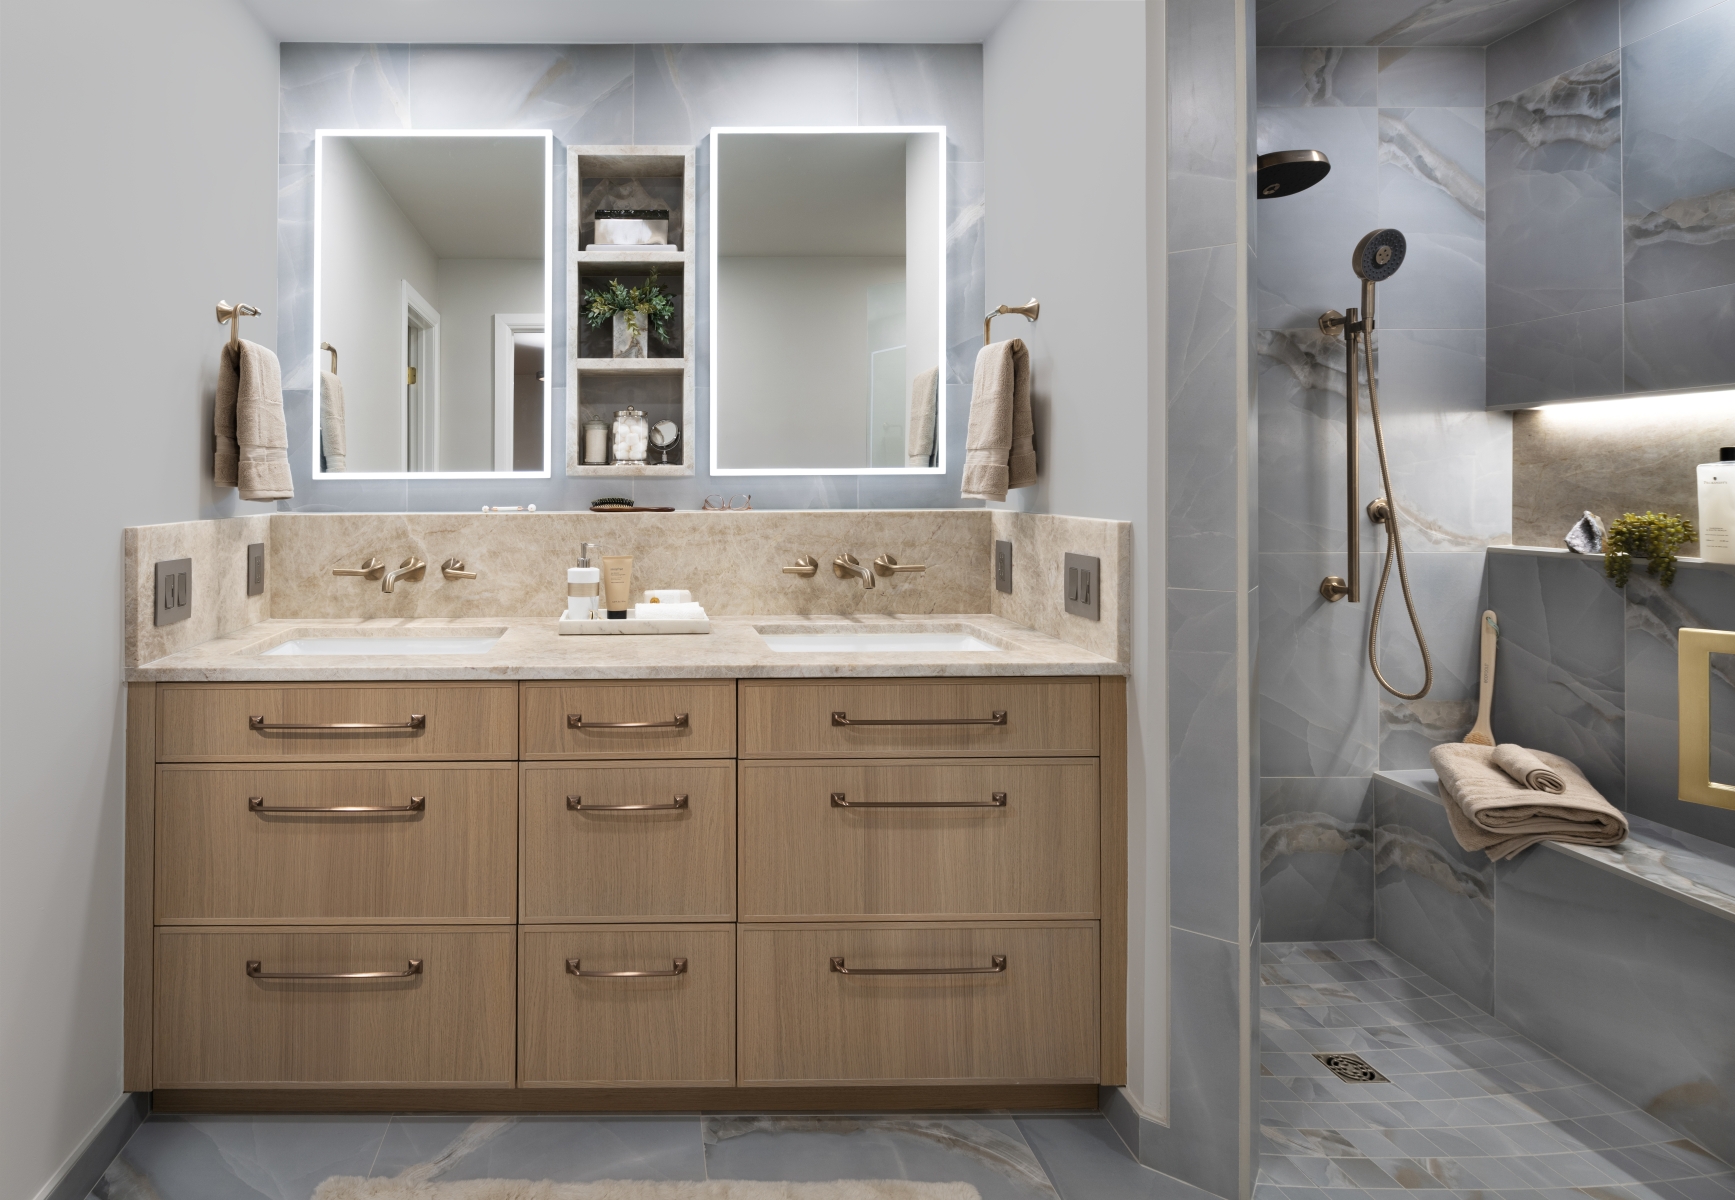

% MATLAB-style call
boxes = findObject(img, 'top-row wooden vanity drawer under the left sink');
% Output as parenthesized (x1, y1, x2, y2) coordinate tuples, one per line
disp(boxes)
(156, 683, 519, 763)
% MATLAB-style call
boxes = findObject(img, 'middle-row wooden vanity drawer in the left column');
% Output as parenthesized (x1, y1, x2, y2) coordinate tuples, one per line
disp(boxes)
(156, 763, 517, 924)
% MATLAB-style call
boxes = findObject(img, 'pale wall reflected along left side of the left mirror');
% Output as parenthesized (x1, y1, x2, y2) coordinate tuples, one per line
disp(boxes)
(320, 137, 440, 472)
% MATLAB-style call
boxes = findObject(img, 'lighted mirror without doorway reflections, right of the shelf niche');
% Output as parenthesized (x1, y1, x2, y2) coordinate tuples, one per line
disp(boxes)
(711, 125, 946, 475)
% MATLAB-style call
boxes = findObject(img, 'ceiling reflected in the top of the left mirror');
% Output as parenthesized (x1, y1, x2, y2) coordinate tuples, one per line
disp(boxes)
(347, 137, 545, 258)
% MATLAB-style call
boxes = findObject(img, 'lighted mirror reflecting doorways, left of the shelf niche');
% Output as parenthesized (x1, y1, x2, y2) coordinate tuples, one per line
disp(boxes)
(305, 130, 553, 479)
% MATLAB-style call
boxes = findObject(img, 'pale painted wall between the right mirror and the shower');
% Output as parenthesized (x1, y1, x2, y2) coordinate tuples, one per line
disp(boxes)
(985, 0, 1168, 1110)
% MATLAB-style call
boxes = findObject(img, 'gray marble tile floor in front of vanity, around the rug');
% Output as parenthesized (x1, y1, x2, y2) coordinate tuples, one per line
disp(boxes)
(90, 1113, 1209, 1200)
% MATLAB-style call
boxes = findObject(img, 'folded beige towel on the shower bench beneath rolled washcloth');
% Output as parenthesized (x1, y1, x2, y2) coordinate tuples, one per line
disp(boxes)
(1428, 742, 1627, 862)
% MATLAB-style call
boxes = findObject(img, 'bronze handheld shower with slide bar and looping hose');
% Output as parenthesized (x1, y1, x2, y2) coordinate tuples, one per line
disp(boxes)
(1319, 229, 1433, 701)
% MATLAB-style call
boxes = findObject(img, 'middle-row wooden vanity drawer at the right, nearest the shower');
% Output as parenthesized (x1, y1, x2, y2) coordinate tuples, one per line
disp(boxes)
(741, 758, 1102, 921)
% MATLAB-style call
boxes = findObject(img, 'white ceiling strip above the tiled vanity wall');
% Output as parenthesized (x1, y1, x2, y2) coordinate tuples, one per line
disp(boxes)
(241, 0, 1017, 43)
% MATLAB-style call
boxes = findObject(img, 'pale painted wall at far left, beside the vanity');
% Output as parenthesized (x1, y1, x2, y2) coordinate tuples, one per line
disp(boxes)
(0, 0, 278, 1200)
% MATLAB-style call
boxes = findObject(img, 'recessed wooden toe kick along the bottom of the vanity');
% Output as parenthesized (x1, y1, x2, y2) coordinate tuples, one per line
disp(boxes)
(152, 1084, 1097, 1116)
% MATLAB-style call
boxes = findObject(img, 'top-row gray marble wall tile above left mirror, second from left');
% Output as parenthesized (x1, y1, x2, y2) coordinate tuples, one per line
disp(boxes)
(409, 45, 633, 143)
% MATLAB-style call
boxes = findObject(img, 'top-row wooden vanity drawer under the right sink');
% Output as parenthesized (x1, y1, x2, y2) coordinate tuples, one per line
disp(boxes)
(741, 676, 1097, 758)
